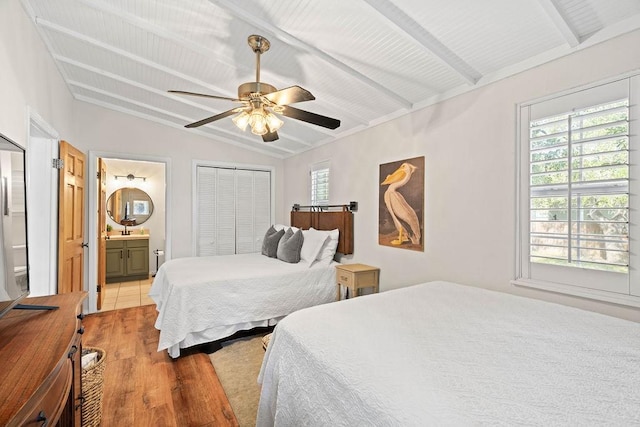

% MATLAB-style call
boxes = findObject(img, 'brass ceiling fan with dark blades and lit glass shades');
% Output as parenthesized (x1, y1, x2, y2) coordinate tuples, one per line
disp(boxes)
(169, 35, 340, 142)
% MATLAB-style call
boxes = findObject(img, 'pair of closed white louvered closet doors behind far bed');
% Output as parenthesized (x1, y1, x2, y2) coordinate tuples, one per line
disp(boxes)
(196, 166, 271, 256)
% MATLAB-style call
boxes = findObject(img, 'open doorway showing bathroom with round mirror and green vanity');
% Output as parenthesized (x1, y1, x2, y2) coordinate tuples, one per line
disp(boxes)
(89, 153, 169, 312)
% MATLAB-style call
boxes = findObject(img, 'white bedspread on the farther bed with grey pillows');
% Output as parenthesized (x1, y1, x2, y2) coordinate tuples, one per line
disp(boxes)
(149, 253, 336, 357)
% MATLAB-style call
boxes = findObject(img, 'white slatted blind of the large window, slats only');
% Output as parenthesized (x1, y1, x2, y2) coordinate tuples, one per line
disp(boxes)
(529, 98, 629, 273)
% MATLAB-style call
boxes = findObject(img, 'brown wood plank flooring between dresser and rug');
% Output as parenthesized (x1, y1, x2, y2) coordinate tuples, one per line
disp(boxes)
(82, 305, 238, 427)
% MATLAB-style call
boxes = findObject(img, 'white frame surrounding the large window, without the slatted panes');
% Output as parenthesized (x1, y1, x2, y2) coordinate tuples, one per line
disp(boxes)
(512, 72, 640, 307)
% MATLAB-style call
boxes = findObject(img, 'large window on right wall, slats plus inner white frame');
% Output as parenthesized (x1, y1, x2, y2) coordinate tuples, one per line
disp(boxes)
(516, 77, 640, 305)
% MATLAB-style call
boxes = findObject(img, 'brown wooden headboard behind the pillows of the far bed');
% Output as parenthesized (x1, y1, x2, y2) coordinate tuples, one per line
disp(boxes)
(291, 205, 353, 255)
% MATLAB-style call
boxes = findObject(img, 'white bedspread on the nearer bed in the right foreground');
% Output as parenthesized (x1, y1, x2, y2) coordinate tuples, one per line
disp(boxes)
(258, 282, 640, 426)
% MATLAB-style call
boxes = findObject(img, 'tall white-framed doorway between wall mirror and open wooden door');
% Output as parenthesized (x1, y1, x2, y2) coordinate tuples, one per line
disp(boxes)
(25, 107, 59, 296)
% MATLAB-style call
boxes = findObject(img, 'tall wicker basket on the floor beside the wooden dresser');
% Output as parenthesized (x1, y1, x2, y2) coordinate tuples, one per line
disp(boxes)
(82, 347, 107, 427)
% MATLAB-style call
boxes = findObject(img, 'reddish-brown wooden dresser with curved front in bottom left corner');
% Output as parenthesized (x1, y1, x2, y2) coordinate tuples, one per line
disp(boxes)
(0, 292, 87, 426)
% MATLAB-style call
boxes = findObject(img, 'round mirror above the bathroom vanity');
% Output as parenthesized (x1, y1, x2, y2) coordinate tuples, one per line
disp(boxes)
(107, 188, 153, 226)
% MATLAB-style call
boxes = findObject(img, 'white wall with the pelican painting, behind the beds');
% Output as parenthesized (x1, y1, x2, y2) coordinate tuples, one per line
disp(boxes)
(282, 31, 640, 321)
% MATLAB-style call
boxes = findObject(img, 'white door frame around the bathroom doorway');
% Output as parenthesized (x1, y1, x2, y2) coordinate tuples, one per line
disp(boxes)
(89, 151, 171, 313)
